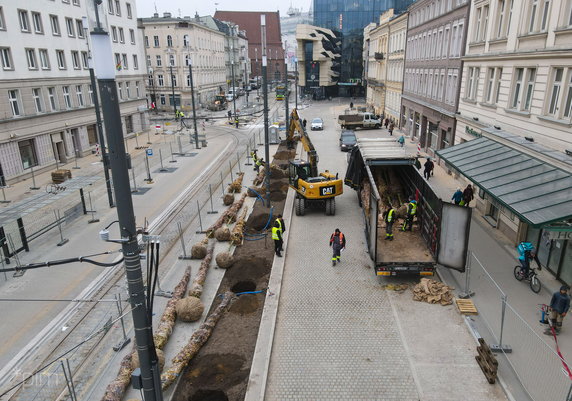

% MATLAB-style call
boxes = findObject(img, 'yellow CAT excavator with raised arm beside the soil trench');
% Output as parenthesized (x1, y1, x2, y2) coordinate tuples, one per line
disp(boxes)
(286, 109, 344, 216)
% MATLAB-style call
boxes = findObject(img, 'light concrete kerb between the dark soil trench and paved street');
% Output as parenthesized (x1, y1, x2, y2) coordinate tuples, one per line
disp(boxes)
(244, 148, 296, 401)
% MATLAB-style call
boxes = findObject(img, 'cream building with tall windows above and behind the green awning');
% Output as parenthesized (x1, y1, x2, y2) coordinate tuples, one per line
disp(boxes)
(446, 0, 572, 284)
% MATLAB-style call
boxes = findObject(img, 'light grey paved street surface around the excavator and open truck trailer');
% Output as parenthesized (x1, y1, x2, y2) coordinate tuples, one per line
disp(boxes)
(246, 101, 506, 401)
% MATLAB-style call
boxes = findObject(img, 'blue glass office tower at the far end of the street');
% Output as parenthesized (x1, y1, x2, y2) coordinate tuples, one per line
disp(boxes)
(313, 0, 415, 96)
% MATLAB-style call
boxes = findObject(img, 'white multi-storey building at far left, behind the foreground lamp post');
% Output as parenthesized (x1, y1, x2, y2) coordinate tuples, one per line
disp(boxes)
(0, 0, 149, 182)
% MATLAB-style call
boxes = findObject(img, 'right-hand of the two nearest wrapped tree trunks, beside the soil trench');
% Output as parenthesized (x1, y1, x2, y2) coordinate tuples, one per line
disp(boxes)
(161, 292, 234, 390)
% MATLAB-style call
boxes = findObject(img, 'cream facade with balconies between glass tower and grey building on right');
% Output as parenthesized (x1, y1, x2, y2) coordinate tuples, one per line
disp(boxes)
(364, 9, 408, 123)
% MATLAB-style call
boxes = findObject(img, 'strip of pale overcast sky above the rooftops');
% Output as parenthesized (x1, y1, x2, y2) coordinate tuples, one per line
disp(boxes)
(137, 0, 312, 18)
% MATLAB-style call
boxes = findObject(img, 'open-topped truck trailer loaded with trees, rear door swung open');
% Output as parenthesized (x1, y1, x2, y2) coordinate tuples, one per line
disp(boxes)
(345, 138, 471, 276)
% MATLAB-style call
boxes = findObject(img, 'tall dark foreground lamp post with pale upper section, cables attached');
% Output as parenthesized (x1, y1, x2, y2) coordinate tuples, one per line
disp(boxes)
(88, 0, 163, 401)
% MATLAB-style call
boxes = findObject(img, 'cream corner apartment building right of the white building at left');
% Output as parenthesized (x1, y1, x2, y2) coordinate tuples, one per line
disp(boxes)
(139, 12, 226, 112)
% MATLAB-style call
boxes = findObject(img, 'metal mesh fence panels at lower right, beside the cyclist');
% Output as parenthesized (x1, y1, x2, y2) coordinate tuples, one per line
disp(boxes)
(464, 252, 572, 401)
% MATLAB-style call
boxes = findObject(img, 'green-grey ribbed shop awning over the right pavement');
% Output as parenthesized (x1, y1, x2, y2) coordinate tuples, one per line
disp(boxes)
(437, 138, 572, 227)
